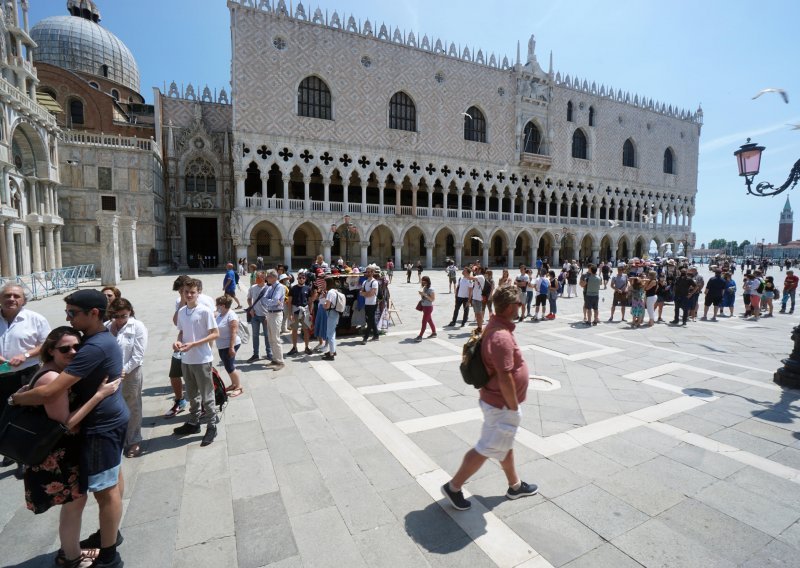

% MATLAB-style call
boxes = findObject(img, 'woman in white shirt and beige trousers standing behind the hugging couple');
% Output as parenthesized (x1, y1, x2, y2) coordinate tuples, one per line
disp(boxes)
(106, 298, 147, 458)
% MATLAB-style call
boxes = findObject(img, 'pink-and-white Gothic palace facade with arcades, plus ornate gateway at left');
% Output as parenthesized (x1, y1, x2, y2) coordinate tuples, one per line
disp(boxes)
(155, 0, 702, 267)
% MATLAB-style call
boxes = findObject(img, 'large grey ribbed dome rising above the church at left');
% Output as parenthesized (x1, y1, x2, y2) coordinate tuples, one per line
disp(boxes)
(31, 10, 139, 93)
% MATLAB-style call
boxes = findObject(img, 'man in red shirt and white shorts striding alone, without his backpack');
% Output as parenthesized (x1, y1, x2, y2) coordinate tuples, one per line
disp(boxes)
(442, 286, 539, 511)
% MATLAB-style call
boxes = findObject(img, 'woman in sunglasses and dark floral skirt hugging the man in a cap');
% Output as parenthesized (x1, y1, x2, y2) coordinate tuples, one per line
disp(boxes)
(23, 326, 120, 568)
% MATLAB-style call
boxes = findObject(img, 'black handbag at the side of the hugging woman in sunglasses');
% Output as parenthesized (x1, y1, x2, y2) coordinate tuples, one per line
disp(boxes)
(0, 377, 67, 466)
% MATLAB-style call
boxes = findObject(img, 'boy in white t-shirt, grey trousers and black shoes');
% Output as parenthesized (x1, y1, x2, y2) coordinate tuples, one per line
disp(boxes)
(172, 278, 219, 446)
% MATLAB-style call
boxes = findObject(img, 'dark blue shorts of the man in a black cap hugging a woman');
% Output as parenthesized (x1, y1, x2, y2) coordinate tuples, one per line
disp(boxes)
(79, 422, 128, 493)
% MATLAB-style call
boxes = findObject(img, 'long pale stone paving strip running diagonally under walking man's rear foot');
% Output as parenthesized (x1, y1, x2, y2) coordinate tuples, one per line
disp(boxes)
(311, 361, 550, 568)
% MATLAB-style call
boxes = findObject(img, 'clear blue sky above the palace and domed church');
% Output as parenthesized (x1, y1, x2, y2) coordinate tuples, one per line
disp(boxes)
(29, 0, 800, 247)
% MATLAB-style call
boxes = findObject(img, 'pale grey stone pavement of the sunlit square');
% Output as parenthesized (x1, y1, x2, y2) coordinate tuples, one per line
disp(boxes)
(0, 268, 800, 568)
